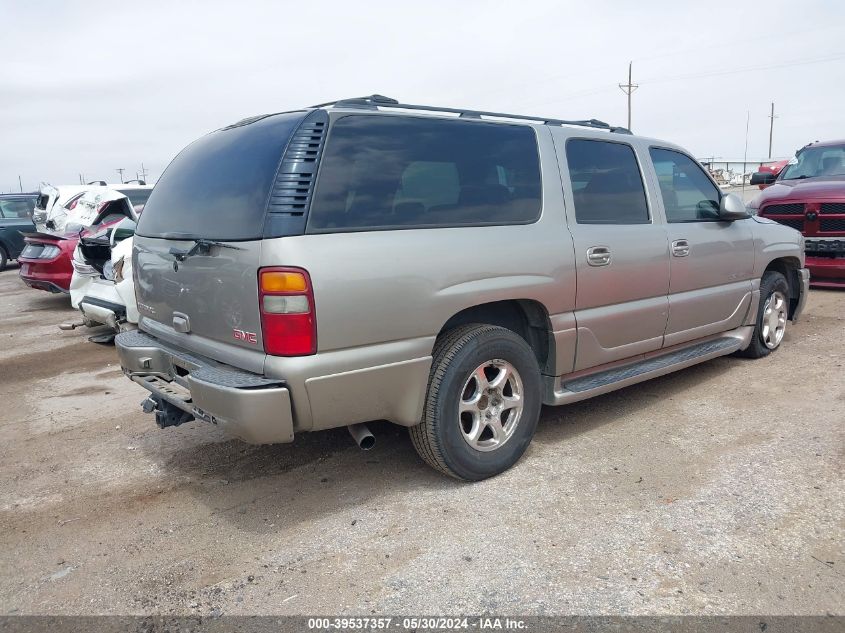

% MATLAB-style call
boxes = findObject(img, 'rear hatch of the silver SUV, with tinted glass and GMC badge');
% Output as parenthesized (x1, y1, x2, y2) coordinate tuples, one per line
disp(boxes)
(133, 112, 324, 373)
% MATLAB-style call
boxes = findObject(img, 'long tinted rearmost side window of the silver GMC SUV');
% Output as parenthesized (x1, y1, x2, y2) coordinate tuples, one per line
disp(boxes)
(308, 115, 540, 232)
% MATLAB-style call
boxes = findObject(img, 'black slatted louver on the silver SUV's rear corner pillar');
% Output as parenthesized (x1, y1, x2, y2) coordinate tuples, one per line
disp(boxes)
(265, 110, 328, 237)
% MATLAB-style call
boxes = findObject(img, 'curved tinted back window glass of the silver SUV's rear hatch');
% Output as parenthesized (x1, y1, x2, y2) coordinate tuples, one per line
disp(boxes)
(137, 112, 304, 240)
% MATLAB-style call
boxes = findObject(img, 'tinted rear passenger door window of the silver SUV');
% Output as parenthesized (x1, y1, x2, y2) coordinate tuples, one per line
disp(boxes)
(566, 139, 649, 224)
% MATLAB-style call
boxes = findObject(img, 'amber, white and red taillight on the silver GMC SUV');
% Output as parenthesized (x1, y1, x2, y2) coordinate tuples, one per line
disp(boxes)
(258, 267, 317, 356)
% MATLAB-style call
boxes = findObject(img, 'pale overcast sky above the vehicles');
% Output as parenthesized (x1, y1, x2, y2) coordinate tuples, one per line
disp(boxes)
(0, 0, 845, 191)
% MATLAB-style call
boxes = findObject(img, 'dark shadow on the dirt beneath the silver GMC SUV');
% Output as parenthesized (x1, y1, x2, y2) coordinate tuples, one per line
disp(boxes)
(157, 359, 739, 533)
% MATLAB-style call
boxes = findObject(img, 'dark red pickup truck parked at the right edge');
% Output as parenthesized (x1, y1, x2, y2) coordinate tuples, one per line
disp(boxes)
(748, 140, 845, 288)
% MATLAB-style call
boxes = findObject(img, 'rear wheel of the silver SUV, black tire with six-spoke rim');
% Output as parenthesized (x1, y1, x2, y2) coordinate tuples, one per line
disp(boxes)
(409, 324, 542, 481)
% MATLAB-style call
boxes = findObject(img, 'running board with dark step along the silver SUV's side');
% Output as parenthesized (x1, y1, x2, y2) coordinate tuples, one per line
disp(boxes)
(545, 326, 754, 405)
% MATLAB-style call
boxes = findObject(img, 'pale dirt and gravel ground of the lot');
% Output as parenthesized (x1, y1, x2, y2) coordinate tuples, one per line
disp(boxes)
(0, 266, 845, 615)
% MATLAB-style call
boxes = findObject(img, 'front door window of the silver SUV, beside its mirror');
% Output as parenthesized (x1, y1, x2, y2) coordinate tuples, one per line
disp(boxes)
(648, 147, 721, 222)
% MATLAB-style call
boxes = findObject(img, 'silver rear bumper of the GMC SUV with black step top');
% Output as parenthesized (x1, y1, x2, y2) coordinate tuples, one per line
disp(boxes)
(115, 332, 293, 444)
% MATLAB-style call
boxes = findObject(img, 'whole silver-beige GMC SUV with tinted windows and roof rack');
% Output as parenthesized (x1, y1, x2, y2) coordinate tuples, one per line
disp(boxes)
(116, 95, 809, 480)
